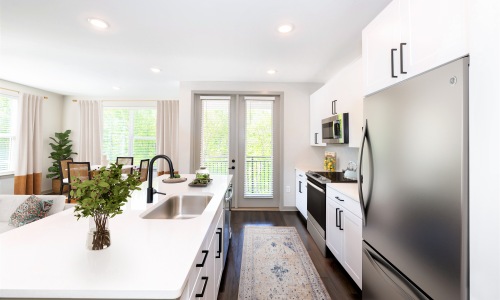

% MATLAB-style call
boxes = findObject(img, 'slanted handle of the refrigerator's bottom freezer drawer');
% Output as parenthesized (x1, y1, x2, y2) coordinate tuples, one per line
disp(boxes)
(363, 247, 430, 299)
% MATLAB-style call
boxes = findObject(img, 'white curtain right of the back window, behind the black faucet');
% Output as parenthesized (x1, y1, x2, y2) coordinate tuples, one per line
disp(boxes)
(156, 100, 179, 175)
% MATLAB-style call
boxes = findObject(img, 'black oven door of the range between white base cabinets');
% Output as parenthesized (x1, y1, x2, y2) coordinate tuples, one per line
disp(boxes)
(307, 179, 326, 232)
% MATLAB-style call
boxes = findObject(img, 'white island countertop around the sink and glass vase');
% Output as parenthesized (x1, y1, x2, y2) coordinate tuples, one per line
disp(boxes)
(0, 175, 232, 299)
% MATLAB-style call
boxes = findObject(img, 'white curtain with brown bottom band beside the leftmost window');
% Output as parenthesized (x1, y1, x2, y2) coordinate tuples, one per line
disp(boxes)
(14, 93, 43, 195)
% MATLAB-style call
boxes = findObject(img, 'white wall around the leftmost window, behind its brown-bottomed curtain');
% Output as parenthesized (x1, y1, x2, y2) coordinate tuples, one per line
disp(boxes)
(0, 80, 63, 194)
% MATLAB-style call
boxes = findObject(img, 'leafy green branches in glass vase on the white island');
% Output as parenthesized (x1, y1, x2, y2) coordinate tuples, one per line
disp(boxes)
(70, 163, 142, 250)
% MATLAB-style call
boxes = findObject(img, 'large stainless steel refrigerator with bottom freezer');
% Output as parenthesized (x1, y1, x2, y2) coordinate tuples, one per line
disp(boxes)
(358, 57, 469, 300)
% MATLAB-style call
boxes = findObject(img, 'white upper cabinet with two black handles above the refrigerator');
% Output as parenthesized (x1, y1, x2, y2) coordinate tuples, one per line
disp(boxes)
(362, 0, 468, 95)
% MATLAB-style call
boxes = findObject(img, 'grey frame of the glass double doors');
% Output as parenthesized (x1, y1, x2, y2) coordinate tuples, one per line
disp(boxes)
(189, 90, 285, 210)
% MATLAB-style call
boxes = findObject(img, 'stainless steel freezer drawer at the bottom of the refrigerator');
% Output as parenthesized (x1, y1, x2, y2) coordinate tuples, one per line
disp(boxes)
(363, 241, 430, 300)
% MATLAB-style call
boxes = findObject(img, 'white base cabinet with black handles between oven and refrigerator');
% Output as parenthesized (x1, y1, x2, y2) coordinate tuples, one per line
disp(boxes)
(326, 187, 363, 288)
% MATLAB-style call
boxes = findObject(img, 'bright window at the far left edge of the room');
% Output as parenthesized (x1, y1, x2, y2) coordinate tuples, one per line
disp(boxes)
(0, 92, 18, 175)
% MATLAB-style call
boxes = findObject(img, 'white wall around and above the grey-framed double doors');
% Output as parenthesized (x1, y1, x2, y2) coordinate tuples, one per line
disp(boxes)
(178, 82, 320, 207)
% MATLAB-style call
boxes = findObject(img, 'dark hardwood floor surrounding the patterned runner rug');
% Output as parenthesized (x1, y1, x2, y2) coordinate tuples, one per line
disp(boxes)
(217, 211, 361, 300)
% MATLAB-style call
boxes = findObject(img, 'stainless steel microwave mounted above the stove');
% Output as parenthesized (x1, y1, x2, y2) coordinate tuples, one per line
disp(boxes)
(321, 113, 349, 144)
